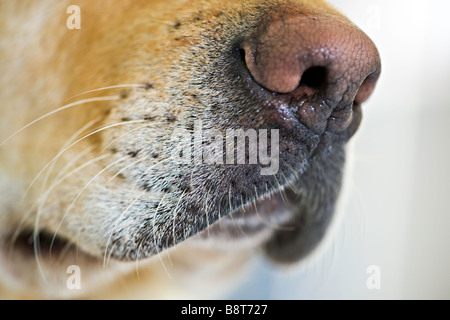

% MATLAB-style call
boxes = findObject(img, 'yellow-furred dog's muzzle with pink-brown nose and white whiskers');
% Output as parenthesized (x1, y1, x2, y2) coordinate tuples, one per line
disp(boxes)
(0, 0, 381, 299)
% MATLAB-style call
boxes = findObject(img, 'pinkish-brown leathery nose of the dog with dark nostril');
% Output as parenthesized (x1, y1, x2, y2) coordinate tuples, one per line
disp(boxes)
(242, 10, 381, 131)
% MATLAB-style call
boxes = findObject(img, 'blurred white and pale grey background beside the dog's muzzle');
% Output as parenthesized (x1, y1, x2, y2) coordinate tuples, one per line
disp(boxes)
(230, 0, 450, 299)
